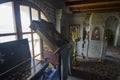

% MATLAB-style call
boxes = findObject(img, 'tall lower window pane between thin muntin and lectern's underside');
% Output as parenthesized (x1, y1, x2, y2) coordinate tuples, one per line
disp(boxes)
(33, 33, 41, 55)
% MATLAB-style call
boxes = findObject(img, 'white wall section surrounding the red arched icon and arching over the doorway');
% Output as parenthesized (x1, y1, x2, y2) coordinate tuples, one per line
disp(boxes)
(88, 13, 120, 58)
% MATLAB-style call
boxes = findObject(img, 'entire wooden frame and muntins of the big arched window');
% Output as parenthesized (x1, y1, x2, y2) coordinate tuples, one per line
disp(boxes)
(0, 0, 48, 58)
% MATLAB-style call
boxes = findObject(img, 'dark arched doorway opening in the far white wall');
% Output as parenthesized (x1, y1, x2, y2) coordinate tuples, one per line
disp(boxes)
(105, 16, 119, 46)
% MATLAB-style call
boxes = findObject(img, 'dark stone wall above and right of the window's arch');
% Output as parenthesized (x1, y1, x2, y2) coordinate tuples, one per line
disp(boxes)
(28, 0, 62, 24)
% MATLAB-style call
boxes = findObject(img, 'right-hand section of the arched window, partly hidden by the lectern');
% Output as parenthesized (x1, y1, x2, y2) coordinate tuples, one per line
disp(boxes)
(20, 5, 48, 59)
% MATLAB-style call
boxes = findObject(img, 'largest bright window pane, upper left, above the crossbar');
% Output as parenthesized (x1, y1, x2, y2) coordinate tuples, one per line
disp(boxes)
(0, 2, 16, 34)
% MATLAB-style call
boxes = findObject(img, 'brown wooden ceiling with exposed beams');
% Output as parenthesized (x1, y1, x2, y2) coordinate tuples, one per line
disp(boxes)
(65, 0, 120, 13)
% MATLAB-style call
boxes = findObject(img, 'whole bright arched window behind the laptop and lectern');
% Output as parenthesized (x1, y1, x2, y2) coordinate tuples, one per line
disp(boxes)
(0, 0, 47, 59)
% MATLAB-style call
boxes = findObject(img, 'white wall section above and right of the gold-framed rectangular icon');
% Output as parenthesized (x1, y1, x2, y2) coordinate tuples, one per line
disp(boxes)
(63, 13, 86, 55)
